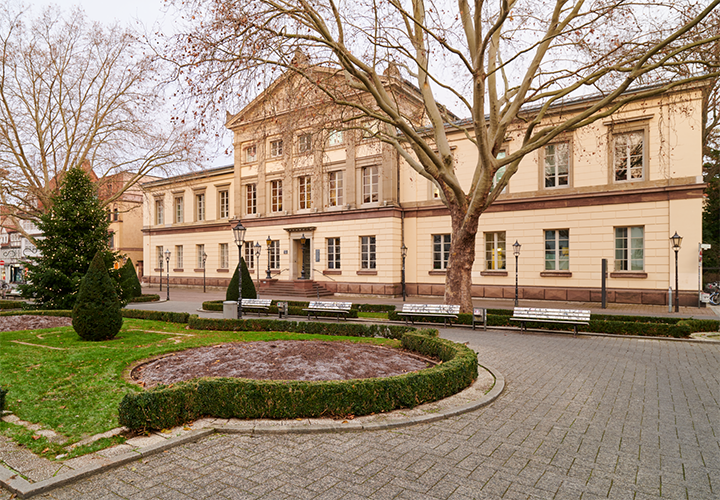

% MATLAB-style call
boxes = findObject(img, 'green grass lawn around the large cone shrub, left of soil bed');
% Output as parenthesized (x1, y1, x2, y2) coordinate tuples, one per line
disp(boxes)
(0, 318, 399, 454)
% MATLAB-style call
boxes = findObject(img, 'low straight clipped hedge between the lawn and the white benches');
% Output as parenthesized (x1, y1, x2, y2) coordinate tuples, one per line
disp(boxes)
(188, 314, 415, 339)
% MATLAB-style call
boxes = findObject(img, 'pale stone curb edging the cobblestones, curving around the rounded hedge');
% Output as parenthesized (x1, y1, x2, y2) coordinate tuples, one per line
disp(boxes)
(0, 365, 505, 498)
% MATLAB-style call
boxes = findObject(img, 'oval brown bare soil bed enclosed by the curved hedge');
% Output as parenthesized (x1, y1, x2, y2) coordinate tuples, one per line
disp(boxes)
(130, 340, 436, 387)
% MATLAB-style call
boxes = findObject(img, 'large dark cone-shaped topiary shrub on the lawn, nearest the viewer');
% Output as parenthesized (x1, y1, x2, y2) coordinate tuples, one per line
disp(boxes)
(72, 252, 123, 340)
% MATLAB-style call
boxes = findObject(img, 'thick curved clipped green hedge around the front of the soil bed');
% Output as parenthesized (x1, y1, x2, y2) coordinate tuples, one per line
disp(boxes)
(119, 333, 478, 430)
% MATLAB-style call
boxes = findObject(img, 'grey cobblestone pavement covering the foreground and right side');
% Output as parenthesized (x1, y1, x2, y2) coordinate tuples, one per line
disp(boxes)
(0, 330, 720, 500)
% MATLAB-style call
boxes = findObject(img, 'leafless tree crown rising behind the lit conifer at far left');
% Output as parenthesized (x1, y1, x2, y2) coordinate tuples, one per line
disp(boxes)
(0, 1, 193, 236)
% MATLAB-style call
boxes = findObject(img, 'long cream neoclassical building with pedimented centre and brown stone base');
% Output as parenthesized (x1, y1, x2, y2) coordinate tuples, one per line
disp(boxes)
(143, 77, 704, 304)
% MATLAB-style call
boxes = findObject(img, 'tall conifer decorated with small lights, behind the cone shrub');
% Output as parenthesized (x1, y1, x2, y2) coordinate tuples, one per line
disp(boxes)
(20, 167, 116, 309)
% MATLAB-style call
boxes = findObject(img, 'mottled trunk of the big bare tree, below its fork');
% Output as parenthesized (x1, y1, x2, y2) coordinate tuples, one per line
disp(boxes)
(445, 207, 480, 313)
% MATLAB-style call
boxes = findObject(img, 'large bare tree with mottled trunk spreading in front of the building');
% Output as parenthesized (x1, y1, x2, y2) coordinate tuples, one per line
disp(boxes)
(167, 0, 720, 311)
